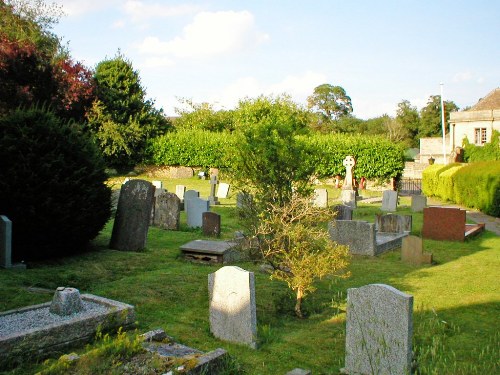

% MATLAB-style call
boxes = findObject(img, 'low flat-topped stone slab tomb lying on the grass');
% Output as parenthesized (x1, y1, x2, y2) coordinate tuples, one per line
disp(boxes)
(180, 240, 241, 264)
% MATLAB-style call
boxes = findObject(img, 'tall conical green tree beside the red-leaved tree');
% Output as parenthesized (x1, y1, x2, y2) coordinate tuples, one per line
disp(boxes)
(89, 54, 170, 169)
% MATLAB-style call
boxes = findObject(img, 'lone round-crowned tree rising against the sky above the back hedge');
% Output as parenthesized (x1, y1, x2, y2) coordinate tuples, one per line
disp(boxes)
(307, 83, 352, 122)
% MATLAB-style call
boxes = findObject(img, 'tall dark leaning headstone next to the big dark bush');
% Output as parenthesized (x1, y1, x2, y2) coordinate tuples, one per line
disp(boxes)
(109, 180, 155, 251)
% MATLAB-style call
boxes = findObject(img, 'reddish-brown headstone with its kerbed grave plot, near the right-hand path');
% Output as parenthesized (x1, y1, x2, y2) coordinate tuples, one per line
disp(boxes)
(422, 207, 485, 241)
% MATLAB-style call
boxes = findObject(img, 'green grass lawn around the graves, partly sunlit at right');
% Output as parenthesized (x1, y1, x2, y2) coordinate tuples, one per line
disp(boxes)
(0, 178, 500, 374)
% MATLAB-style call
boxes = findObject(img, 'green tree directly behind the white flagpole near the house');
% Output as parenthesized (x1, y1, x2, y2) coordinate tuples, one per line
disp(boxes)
(418, 95, 458, 138)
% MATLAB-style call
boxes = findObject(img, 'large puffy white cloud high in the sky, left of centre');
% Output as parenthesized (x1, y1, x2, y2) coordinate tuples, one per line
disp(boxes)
(138, 11, 269, 58)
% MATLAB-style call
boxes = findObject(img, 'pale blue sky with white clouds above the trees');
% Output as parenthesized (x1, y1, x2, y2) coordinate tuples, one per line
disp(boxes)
(53, 0, 500, 119)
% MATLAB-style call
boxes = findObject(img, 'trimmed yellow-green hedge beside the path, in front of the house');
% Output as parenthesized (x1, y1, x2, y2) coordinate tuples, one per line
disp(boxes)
(422, 161, 500, 217)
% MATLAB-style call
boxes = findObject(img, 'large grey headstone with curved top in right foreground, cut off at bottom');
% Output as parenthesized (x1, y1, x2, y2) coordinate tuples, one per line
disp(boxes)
(345, 284, 413, 374)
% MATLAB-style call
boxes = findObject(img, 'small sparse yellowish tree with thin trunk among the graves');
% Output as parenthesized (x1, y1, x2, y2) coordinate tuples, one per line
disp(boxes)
(258, 195, 349, 318)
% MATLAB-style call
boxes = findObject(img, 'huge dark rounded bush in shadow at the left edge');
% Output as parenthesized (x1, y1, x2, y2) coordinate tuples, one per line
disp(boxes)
(0, 109, 111, 260)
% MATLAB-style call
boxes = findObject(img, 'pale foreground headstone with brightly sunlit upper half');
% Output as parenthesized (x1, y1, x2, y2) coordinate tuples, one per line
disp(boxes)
(208, 266, 257, 349)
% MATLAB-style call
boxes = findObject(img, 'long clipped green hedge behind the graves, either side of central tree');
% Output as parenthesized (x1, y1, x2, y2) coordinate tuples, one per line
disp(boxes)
(146, 130, 404, 180)
